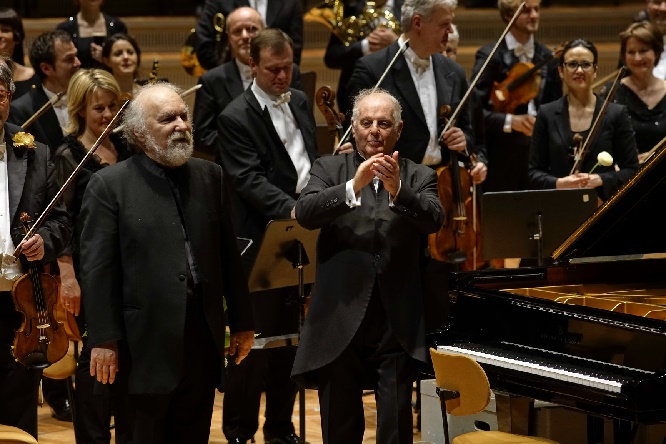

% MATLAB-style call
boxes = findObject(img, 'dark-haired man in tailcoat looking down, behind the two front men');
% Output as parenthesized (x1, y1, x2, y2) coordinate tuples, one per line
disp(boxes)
(217, 28, 317, 444)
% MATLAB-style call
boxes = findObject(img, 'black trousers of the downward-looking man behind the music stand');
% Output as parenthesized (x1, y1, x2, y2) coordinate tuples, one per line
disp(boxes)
(222, 288, 298, 439)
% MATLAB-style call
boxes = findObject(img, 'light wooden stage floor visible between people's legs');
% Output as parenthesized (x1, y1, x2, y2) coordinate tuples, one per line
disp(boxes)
(39, 390, 421, 444)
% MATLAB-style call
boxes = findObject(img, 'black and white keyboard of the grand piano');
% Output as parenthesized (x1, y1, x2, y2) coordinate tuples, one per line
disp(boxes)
(437, 344, 650, 393)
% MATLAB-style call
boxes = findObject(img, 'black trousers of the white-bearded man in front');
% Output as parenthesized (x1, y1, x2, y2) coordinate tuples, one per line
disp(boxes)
(128, 299, 221, 444)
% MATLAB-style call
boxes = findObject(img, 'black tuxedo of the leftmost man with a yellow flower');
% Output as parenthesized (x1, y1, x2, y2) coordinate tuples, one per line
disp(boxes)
(0, 123, 72, 438)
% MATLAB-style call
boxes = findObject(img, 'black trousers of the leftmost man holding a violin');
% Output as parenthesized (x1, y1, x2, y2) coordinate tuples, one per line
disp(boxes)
(0, 291, 42, 438)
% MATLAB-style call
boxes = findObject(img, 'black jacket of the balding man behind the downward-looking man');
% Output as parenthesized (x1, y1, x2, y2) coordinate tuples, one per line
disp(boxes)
(192, 60, 302, 158)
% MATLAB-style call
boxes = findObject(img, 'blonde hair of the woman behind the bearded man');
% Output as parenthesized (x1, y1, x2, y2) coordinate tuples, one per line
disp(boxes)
(65, 69, 120, 137)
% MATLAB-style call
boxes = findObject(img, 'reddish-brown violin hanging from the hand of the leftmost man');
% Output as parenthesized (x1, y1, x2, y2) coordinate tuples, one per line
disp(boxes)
(11, 213, 69, 369)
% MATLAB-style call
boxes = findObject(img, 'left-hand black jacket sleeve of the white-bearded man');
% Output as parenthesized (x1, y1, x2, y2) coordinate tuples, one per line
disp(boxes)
(80, 174, 123, 347)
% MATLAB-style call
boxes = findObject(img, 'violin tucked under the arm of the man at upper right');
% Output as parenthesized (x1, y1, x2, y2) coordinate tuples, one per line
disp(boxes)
(490, 46, 563, 113)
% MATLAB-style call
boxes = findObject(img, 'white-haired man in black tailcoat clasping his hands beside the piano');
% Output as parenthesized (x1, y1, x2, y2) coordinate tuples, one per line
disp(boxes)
(292, 90, 443, 444)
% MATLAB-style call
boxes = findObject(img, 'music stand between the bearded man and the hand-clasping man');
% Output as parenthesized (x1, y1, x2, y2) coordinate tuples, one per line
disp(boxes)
(249, 219, 319, 443)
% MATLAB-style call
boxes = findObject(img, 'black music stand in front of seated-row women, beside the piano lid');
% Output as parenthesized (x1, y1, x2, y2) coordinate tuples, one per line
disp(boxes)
(481, 188, 597, 266)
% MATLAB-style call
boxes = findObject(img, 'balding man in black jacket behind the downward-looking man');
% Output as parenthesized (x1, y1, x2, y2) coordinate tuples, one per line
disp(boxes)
(192, 6, 301, 163)
